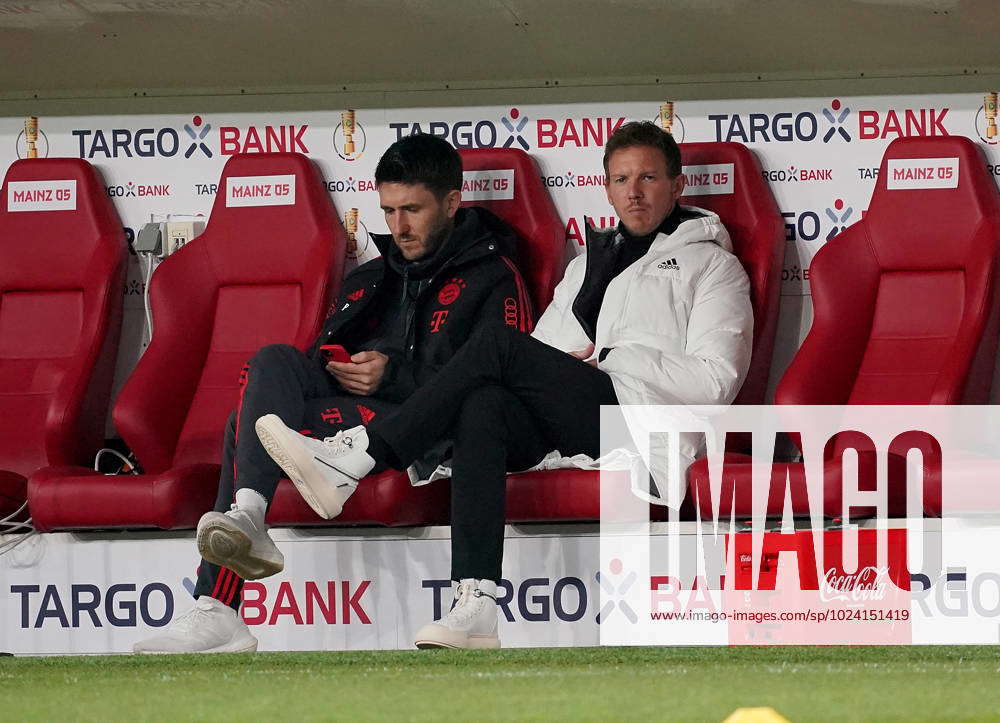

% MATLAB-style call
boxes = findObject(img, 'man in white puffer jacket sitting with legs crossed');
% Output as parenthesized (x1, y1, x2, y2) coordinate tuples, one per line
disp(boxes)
(256, 122, 753, 648)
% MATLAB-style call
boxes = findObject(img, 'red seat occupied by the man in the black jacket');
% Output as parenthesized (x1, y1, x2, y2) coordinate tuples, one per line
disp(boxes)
(268, 148, 566, 526)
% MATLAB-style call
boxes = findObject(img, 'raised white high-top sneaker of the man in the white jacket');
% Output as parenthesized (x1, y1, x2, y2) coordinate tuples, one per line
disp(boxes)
(255, 414, 375, 520)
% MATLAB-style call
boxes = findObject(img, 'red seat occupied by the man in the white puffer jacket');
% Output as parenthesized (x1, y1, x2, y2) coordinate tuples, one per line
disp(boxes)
(507, 143, 785, 522)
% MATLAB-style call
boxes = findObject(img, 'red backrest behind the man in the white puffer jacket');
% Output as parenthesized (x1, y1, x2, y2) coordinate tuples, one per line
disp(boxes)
(680, 143, 785, 404)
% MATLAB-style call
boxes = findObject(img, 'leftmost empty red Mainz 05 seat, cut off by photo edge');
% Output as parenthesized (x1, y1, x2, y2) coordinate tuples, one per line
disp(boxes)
(0, 158, 127, 517)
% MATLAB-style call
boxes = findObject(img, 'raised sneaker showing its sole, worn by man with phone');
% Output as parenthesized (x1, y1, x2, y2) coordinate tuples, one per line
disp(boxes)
(198, 505, 285, 580)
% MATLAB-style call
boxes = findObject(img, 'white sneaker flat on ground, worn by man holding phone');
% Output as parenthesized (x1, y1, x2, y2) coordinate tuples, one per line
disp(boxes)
(132, 595, 257, 653)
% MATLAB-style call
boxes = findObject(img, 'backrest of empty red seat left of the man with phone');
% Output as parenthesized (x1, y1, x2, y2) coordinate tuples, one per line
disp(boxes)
(114, 153, 346, 472)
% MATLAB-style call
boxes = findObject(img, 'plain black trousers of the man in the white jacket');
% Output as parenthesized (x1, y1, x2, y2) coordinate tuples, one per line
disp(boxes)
(368, 324, 618, 581)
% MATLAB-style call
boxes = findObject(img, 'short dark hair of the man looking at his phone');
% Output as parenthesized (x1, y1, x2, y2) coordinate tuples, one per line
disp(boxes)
(375, 133, 462, 198)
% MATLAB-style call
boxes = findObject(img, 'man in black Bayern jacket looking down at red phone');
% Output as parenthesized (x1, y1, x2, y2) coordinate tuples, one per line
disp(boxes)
(135, 135, 532, 652)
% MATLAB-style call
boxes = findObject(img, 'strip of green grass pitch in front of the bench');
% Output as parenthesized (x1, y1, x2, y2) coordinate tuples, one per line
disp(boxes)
(0, 646, 1000, 721)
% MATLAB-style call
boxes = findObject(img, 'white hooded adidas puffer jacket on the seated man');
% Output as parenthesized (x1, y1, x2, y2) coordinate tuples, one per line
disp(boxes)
(532, 208, 753, 506)
